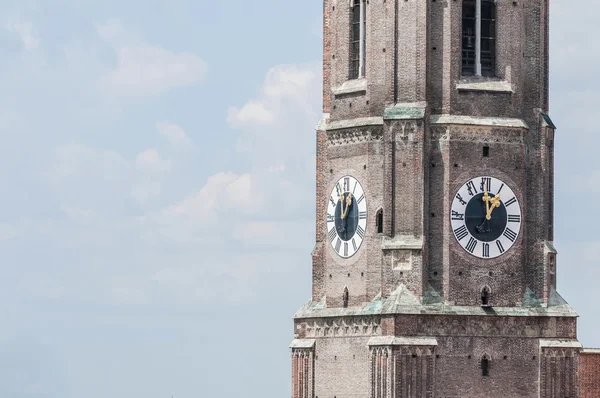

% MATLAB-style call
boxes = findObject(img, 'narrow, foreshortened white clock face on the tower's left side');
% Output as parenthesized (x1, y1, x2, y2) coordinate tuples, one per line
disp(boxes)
(327, 176, 367, 258)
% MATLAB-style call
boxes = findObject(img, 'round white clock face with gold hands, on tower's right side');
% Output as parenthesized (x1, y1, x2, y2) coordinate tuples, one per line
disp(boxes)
(450, 176, 522, 259)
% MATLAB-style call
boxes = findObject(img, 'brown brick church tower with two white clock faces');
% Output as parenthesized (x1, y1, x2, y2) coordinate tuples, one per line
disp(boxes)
(291, 0, 581, 398)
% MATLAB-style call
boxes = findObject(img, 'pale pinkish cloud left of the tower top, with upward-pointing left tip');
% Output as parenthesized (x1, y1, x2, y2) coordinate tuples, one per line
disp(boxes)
(96, 21, 207, 97)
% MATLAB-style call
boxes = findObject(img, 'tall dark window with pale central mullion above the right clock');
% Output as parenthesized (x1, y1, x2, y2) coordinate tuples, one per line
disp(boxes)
(462, 0, 496, 77)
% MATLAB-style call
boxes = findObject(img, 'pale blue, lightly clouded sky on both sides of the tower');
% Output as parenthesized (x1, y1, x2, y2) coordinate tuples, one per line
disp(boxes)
(0, 0, 600, 398)
